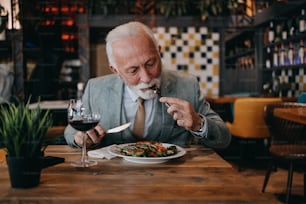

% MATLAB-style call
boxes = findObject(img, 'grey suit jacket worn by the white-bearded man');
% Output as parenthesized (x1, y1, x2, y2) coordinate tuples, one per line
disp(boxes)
(65, 71, 231, 148)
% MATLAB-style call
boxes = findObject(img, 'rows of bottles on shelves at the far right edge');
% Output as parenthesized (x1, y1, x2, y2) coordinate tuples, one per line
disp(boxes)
(262, 6, 306, 96)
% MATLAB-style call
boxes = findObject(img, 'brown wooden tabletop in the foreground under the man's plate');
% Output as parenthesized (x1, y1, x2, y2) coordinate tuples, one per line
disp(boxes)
(0, 145, 278, 204)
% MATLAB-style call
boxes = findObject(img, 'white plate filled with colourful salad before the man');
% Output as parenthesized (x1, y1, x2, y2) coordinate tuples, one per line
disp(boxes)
(108, 141, 186, 164)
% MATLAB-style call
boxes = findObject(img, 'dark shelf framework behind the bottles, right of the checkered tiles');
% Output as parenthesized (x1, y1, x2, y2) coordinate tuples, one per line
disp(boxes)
(221, 0, 306, 96)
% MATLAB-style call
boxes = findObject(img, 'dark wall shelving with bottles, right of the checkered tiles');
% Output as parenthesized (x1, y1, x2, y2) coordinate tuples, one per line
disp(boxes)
(220, 1, 306, 96)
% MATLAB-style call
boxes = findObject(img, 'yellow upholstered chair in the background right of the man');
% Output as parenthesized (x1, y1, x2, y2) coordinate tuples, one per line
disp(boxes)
(226, 97, 282, 170)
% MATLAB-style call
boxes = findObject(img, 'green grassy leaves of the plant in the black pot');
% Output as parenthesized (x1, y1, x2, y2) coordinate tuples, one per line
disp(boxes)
(0, 100, 53, 158)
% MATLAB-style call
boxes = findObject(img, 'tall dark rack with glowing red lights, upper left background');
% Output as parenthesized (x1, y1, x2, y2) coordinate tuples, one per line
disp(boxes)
(22, 0, 87, 101)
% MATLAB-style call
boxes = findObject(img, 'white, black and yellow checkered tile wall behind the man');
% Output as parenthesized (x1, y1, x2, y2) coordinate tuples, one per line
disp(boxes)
(154, 27, 220, 95)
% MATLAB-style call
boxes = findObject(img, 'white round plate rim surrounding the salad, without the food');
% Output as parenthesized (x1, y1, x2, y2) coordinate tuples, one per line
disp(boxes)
(107, 143, 186, 164)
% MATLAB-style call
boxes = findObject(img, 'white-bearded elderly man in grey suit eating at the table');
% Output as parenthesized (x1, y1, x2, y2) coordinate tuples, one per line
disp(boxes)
(65, 22, 231, 148)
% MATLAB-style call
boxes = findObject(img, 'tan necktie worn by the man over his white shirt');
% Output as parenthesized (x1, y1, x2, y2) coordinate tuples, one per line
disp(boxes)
(133, 98, 145, 138)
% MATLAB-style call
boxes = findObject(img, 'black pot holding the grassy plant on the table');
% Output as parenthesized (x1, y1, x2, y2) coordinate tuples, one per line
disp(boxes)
(6, 156, 41, 188)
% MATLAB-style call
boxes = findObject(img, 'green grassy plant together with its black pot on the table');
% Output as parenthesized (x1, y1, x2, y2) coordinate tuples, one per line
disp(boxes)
(0, 100, 53, 188)
